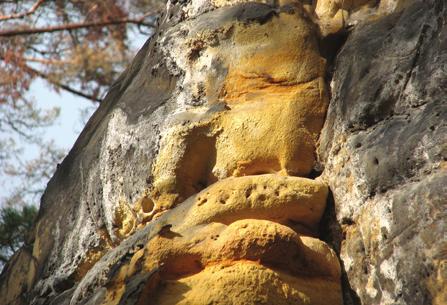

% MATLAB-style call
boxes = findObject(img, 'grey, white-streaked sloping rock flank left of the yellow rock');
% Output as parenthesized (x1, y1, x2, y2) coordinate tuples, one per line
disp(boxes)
(0, 3, 183, 304)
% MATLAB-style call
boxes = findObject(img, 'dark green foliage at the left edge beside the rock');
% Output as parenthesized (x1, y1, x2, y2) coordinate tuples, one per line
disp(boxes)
(0, 205, 37, 267)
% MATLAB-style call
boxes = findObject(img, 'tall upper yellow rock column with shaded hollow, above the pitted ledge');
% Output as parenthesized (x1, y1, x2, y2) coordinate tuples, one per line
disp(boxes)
(151, 7, 328, 210)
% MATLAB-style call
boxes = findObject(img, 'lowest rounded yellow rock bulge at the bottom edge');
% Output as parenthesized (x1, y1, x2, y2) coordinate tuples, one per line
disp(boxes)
(154, 261, 341, 305)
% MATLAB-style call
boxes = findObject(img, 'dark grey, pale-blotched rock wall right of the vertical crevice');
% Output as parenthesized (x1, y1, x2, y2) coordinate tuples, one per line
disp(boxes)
(319, 1, 447, 304)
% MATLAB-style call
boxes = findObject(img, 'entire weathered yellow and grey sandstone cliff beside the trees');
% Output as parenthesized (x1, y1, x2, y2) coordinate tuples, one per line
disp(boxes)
(0, 0, 447, 305)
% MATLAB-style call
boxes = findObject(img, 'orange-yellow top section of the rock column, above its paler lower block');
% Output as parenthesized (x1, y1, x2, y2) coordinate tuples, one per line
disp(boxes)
(221, 11, 325, 103)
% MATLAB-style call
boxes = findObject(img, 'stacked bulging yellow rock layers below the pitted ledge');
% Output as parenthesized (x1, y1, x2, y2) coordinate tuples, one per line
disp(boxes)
(107, 219, 341, 304)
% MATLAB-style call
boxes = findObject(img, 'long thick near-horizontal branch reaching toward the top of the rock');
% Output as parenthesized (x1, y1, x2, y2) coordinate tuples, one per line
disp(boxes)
(0, 15, 155, 37)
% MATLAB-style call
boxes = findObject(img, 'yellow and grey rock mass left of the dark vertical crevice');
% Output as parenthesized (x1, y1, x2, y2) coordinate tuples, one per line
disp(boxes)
(2, 2, 341, 304)
